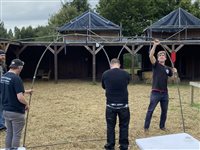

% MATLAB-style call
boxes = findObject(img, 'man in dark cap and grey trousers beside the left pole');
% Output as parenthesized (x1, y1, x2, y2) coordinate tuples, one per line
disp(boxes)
(1, 59, 32, 148)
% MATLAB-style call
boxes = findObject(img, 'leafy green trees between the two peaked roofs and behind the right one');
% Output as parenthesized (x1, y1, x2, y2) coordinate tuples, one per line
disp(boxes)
(97, 0, 200, 36)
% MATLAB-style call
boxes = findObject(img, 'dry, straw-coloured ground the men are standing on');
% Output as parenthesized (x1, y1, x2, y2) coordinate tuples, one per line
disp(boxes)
(0, 80, 200, 150)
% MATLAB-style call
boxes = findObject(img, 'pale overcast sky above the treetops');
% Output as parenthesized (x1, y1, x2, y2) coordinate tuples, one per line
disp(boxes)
(0, 0, 98, 30)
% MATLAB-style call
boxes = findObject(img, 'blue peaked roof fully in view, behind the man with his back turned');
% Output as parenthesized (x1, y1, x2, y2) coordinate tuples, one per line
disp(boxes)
(57, 10, 120, 32)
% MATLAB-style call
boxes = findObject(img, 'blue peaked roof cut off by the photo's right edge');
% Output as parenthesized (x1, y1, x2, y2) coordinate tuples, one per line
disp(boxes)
(145, 8, 200, 32)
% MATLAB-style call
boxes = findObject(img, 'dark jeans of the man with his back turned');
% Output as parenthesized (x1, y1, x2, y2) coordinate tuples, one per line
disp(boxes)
(105, 107, 130, 150)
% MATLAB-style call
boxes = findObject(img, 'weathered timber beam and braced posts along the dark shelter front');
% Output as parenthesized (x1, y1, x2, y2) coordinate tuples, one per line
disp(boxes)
(0, 40, 200, 83)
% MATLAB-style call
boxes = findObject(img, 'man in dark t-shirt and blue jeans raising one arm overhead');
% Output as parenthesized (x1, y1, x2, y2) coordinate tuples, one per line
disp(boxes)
(144, 40, 177, 131)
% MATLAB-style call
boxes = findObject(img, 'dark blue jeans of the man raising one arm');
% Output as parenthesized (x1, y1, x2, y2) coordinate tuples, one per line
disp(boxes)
(144, 91, 169, 129)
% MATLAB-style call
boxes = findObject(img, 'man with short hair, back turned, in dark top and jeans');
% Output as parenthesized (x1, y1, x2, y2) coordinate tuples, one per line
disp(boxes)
(102, 58, 130, 150)
